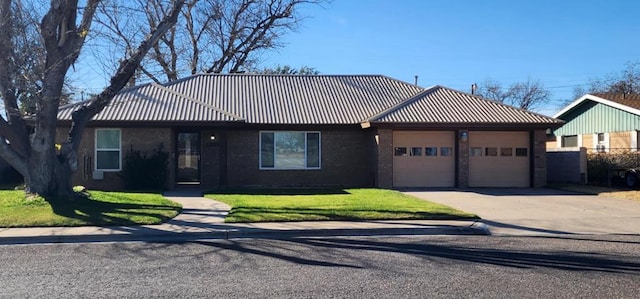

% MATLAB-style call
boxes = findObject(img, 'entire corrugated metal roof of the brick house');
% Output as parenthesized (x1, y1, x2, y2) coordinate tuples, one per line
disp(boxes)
(58, 74, 558, 124)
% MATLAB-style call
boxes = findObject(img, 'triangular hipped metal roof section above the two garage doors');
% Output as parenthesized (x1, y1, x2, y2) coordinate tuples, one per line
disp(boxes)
(368, 86, 560, 124)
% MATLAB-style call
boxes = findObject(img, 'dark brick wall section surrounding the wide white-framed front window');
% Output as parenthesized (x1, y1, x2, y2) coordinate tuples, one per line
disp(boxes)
(225, 128, 373, 187)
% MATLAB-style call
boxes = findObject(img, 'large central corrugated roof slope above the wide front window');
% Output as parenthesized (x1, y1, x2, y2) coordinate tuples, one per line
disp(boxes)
(161, 74, 423, 124)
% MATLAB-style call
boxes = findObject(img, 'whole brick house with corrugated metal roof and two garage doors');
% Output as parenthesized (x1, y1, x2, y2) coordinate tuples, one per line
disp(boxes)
(58, 74, 561, 189)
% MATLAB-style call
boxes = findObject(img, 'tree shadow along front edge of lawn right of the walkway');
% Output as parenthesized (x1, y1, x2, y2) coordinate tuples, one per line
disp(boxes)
(228, 207, 480, 222)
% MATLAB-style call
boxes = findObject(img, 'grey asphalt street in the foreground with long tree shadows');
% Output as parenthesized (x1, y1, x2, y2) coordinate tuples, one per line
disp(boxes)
(0, 235, 640, 298)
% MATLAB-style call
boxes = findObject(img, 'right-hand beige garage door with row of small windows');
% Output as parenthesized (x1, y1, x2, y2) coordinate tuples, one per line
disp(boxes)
(469, 131, 531, 187)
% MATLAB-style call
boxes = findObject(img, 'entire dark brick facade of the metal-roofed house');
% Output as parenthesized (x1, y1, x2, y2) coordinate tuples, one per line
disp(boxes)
(58, 127, 547, 190)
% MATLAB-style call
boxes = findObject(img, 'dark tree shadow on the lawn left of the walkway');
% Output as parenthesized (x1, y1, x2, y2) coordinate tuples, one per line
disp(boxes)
(45, 197, 182, 226)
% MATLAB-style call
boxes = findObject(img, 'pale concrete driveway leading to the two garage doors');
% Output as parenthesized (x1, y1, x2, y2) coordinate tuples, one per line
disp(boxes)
(401, 188, 640, 235)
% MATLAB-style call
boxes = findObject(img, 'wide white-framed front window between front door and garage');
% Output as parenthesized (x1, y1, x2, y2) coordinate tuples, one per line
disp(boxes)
(260, 132, 320, 169)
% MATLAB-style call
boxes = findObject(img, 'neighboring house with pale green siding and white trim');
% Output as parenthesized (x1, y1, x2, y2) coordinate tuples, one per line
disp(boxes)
(547, 94, 640, 153)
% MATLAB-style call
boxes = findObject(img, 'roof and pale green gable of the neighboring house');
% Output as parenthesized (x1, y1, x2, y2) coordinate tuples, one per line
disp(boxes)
(554, 94, 640, 136)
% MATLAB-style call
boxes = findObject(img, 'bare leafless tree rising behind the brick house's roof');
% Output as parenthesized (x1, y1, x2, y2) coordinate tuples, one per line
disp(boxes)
(98, 0, 326, 82)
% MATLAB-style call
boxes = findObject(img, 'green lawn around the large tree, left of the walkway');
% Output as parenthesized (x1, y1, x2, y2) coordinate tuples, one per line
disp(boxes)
(0, 190, 182, 227)
